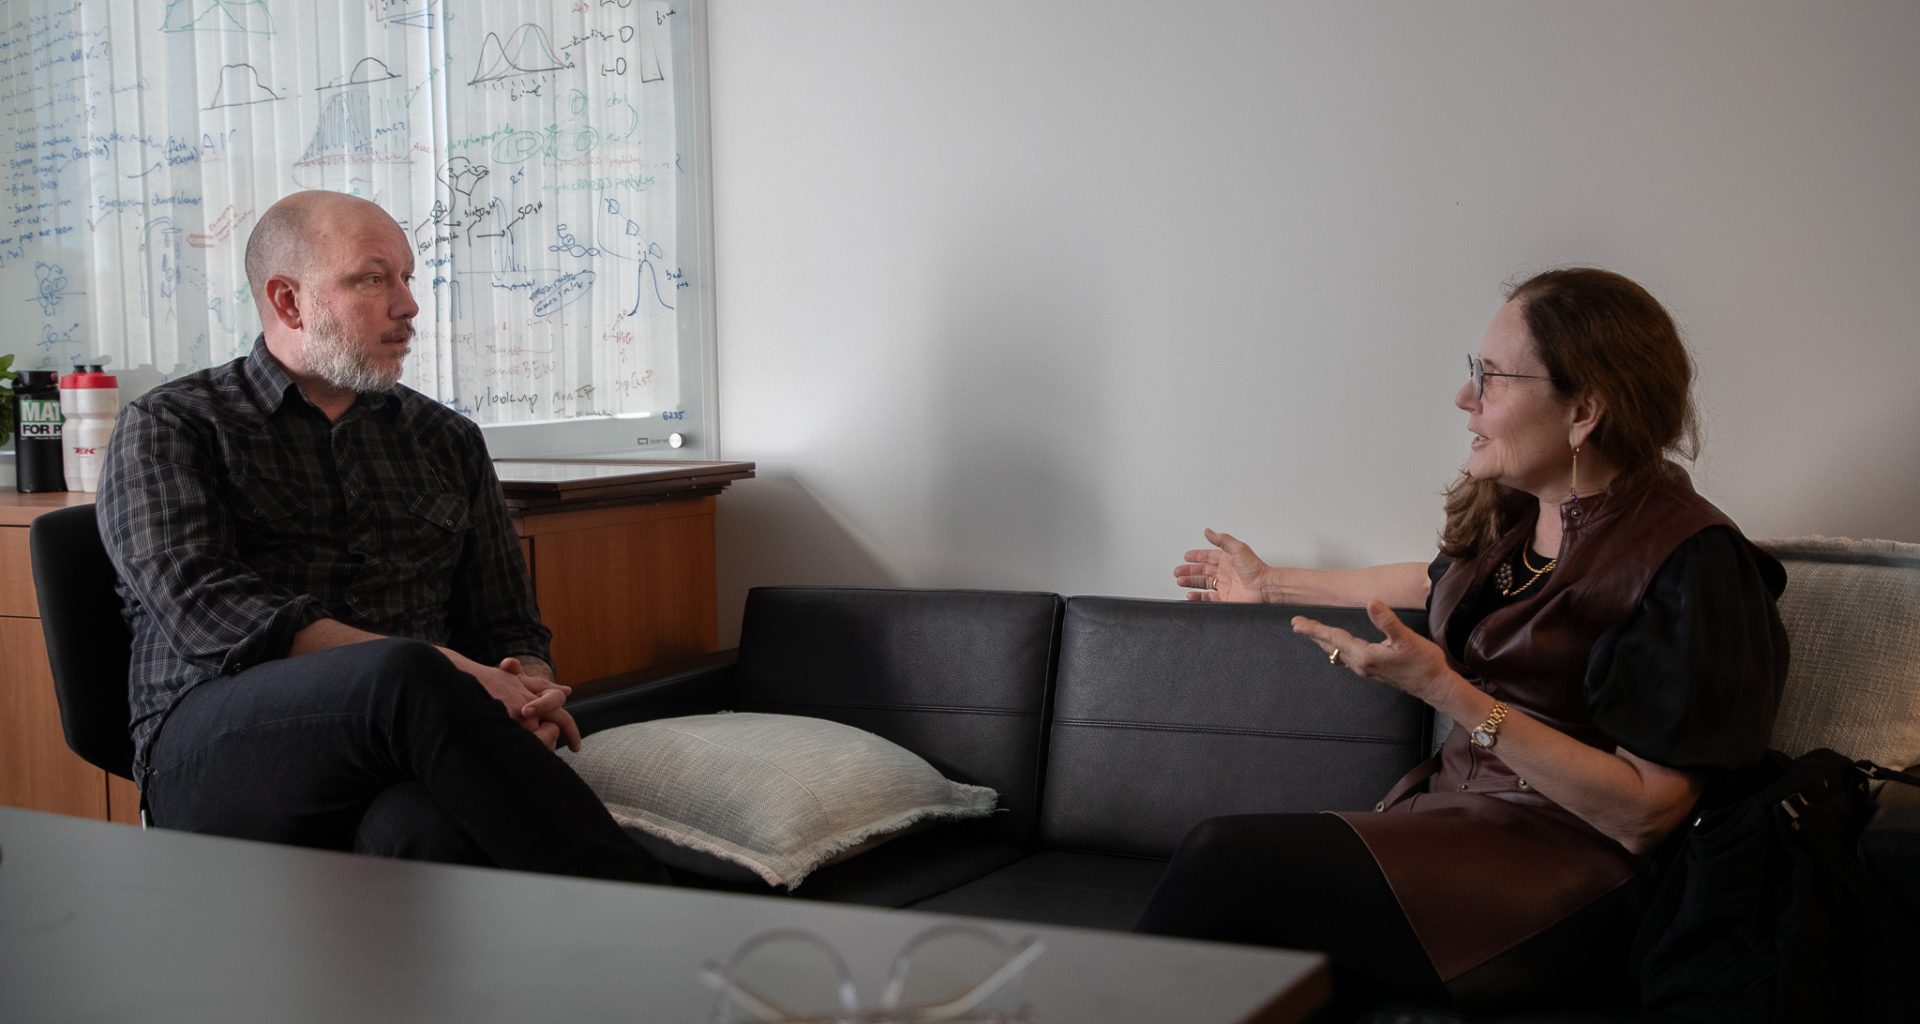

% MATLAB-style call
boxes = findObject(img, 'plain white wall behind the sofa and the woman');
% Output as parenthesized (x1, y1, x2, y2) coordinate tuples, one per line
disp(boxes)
(710, 0, 1920, 632)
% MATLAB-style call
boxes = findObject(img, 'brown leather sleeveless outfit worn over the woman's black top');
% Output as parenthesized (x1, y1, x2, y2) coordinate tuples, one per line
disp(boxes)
(1340, 467, 1732, 984)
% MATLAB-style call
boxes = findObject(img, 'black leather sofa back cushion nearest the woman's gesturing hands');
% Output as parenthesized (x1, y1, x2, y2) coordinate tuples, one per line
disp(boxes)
(1041, 597, 1428, 857)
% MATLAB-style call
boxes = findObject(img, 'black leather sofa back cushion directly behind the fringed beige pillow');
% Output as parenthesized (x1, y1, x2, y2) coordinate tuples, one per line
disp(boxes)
(730, 586, 1062, 843)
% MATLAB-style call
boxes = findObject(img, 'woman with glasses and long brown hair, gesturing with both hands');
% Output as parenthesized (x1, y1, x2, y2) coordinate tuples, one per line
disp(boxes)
(1140, 267, 1788, 1005)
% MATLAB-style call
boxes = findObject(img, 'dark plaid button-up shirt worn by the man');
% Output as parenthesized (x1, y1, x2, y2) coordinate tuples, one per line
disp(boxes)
(98, 340, 551, 778)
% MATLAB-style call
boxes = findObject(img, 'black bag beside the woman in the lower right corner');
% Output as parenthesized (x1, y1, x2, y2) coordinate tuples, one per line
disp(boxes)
(1634, 747, 1920, 1024)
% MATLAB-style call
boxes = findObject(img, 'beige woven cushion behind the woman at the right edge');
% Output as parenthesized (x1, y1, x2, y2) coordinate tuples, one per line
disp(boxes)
(1761, 536, 1920, 768)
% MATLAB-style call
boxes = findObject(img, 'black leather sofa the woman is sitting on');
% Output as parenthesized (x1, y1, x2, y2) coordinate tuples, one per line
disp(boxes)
(574, 588, 1920, 1024)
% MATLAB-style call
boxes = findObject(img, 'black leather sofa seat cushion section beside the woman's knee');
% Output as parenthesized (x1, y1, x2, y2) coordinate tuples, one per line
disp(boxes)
(912, 851, 1167, 932)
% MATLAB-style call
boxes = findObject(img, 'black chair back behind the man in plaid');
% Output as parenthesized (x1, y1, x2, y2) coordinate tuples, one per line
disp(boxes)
(27, 505, 132, 778)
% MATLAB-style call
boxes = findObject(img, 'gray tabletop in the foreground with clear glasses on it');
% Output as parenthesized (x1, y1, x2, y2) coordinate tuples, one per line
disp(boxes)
(0, 807, 1329, 1024)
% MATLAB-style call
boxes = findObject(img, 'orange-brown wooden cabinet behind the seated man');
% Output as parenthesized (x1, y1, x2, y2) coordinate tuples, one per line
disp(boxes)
(0, 470, 741, 822)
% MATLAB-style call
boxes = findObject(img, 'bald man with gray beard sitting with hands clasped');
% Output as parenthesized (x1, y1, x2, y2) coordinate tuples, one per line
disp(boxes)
(98, 192, 660, 880)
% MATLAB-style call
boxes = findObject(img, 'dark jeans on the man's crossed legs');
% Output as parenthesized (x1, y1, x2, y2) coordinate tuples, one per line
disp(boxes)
(144, 640, 664, 882)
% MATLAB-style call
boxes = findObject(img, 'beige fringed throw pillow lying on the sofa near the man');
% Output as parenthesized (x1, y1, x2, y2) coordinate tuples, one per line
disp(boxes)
(563, 713, 996, 890)
